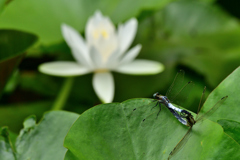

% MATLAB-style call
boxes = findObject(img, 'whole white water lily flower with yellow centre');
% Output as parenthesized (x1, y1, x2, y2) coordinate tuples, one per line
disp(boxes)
(39, 11, 164, 103)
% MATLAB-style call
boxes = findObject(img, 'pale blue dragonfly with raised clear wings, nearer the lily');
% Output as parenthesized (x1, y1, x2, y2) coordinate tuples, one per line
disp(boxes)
(133, 70, 194, 125)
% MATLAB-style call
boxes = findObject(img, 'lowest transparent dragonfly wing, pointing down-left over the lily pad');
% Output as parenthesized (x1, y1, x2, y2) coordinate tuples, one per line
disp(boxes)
(168, 127, 192, 160)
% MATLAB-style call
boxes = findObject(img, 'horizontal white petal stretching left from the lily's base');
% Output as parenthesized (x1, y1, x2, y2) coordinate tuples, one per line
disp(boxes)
(38, 61, 91, 77)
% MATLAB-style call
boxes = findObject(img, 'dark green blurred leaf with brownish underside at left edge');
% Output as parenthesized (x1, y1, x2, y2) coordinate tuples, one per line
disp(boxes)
(0, 30, 37, 96)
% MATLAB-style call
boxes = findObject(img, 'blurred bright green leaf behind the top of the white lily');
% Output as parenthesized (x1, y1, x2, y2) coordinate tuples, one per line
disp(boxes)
(0, 0, 172, 44)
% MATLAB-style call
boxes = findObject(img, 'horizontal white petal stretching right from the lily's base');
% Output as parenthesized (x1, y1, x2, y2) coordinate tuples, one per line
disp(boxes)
(115, 60, 164, 75)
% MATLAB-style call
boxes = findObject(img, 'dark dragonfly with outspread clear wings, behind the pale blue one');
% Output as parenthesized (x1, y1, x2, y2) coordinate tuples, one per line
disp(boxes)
(168, 87, 228, 160)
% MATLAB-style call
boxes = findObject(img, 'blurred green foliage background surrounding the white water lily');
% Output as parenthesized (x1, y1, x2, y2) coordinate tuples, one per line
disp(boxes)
(0, 0, 240, 132)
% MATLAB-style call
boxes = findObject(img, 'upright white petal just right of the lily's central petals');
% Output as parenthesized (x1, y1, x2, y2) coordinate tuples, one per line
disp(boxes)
(118, 18, 138, 53)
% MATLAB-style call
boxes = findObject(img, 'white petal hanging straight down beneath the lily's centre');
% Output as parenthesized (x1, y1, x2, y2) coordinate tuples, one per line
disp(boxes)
(93, 72, 114, 103)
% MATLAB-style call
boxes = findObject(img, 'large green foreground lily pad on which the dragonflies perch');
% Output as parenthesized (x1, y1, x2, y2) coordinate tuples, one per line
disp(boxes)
(64, 99, 240, 160)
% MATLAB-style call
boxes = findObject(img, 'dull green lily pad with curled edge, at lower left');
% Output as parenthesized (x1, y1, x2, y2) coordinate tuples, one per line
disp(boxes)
(13, 111, 79, 160)
